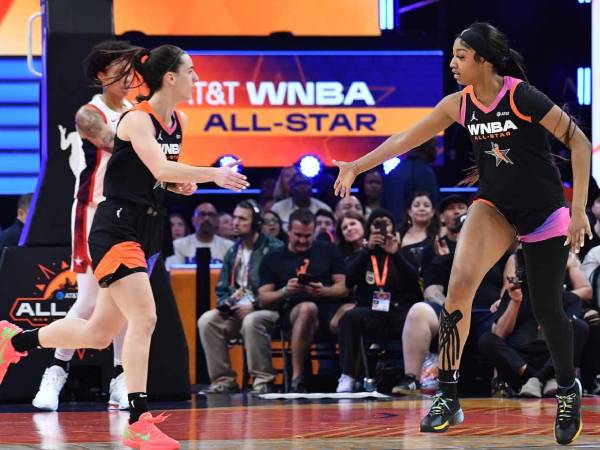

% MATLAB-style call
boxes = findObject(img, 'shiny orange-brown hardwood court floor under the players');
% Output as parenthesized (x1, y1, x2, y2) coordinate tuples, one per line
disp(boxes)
(0, 395, 600, 450)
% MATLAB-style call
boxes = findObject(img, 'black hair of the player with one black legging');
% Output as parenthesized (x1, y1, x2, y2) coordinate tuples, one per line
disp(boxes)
(456, 22, 528, 81)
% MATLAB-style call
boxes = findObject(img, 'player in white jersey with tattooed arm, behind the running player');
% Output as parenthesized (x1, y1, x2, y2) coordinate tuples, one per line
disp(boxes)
(32, 41, 132, 411)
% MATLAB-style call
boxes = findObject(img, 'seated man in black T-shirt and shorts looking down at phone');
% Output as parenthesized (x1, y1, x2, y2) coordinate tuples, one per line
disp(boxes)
(258, 209, 347, 392)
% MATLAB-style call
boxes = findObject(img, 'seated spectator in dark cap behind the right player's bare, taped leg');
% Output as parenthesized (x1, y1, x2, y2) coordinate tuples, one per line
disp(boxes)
(392, 196, 509, 395)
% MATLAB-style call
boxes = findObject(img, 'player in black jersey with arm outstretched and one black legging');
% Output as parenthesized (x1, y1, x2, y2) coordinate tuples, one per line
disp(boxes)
(334, 23, 591, 444)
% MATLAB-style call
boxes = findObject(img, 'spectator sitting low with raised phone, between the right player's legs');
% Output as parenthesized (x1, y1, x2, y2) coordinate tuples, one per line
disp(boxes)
(479, 250, 588, 398)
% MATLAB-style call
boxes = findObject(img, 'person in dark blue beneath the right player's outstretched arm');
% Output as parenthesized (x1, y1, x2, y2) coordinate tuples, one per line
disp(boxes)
(383, 138, 439, 220)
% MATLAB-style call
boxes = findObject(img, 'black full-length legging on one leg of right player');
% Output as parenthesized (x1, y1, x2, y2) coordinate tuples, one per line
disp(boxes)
(523, 236, 575, 387)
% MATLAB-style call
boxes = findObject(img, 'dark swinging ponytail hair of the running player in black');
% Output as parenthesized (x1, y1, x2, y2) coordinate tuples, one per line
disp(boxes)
(89, 44, 185, 102)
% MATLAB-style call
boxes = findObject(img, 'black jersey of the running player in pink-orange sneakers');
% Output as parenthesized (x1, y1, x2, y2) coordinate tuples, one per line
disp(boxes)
(104, 101, 183, 209)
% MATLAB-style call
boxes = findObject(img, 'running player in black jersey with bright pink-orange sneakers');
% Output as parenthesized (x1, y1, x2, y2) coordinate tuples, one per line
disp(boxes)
(0, 45, 248, 450)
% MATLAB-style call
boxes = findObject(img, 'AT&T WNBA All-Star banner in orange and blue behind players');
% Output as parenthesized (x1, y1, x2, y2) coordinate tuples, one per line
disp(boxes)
(176, 50, 443, 167)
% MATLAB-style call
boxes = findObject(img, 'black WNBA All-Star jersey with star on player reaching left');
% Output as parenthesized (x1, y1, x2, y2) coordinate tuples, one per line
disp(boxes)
(460, 76, 565, 211)
